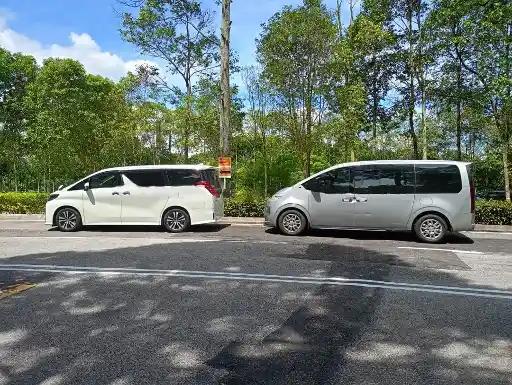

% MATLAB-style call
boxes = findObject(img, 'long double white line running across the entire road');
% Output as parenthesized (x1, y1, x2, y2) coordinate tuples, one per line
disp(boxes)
(0, 264, 512, 300)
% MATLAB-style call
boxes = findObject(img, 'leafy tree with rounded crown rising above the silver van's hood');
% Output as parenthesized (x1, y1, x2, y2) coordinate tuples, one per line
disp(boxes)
(257, 0, 336, 176)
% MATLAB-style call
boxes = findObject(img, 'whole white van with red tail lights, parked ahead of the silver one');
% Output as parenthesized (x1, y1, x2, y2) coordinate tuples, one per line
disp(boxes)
(45, 165, 224, 233)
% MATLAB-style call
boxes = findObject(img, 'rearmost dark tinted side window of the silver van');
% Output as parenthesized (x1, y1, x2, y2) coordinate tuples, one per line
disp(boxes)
(415, 164, 462, 194)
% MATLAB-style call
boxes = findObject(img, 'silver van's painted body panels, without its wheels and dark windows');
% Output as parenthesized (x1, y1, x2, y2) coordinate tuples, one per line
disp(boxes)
(265, 160, 474, 231)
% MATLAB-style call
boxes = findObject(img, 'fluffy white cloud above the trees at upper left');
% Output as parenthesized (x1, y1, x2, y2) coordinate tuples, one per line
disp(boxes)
(0, 12, 154, 80)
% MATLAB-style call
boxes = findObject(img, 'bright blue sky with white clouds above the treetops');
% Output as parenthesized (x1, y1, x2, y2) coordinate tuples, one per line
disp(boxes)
(0, 0, 358, 85)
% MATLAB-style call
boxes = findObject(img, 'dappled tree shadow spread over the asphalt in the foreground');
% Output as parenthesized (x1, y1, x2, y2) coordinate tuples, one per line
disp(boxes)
(0, 243, 512, 385)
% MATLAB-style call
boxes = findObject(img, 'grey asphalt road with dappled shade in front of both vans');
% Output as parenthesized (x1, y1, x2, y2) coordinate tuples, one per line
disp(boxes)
(0, 220, 512, 385)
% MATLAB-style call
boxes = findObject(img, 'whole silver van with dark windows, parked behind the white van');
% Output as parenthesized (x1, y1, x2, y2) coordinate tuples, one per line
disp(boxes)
(265, 160, 475, 243)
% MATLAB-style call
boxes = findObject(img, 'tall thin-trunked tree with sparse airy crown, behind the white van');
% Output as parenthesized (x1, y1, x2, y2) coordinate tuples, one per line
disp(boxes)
(121, 0, 219, 161)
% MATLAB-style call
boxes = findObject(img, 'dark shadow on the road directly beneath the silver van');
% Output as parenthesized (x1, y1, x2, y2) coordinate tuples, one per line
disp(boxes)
(265, 228, 475, 245)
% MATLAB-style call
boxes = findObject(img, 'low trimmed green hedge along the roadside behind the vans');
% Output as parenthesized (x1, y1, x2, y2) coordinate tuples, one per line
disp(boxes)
(0, 192, 512, 226)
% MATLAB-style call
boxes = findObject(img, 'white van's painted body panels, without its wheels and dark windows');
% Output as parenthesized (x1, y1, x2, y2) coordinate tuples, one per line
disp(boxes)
(45, 165, 224, 226)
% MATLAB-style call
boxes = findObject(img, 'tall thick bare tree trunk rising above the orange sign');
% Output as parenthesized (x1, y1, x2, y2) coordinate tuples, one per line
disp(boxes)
(220, 0, 231, 156)
